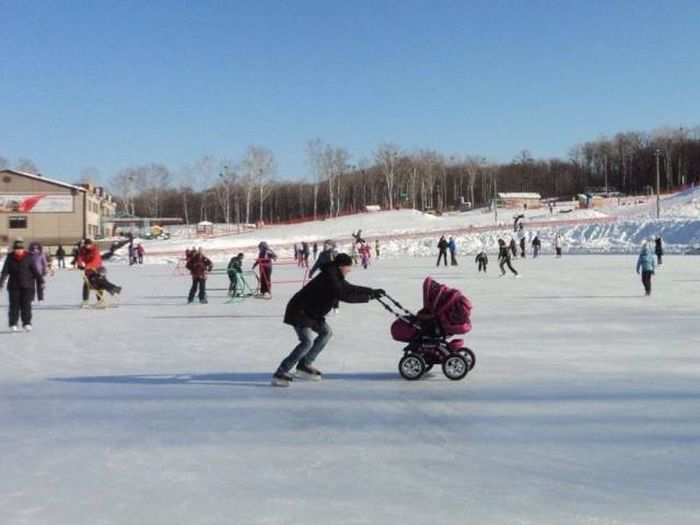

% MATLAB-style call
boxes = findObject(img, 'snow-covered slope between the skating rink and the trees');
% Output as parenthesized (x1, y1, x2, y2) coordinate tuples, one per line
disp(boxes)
(115, 188, 700, 263)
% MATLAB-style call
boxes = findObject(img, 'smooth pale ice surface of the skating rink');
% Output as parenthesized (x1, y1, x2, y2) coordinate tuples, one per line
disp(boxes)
(0, 253, 700, 525)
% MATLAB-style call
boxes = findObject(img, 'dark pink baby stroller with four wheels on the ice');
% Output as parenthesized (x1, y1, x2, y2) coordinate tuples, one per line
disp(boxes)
(379, 277, 476, 381)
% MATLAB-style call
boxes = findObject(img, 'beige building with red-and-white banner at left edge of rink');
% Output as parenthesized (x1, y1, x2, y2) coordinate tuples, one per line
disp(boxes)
(0, 169, 116, 249)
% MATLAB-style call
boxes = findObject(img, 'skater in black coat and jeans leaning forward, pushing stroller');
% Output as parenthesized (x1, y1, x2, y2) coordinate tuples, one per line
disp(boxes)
(272, 253, 385, 386)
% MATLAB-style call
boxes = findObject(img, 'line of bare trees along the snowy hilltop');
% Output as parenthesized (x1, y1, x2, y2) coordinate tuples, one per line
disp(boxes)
(0, 126, 700, 224)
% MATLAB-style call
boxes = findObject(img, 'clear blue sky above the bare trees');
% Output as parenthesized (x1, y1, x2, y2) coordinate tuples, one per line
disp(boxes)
(0, 0, 700, 182)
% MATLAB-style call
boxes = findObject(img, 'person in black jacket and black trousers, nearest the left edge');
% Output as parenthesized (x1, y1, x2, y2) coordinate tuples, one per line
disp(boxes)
(0, 239, 44, 332)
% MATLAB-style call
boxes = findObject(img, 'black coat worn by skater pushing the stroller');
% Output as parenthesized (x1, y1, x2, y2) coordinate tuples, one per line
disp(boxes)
(284, 262, 372, 329)
